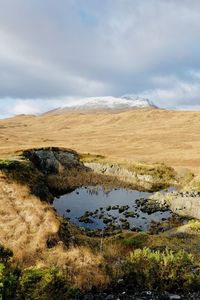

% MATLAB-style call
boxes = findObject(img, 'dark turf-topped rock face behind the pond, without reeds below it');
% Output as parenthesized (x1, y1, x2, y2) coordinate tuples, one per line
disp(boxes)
(23, 147, 86, 175)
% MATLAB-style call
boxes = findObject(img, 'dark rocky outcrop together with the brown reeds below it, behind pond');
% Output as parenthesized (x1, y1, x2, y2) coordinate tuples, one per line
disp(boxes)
(23, 147, 88, 196)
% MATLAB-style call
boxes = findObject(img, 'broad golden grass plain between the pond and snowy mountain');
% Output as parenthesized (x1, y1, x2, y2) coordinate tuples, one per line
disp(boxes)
(0, 109, 200, 172)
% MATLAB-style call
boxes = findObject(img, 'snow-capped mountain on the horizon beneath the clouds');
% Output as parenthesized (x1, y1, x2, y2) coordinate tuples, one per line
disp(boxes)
(44, 95, 157, 113)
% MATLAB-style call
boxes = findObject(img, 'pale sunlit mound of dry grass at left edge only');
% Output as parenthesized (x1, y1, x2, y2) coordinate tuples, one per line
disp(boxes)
(0, 173, 59, 265)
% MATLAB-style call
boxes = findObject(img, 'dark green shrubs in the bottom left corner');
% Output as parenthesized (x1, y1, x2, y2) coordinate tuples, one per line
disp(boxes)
(0, 246, 75, 300)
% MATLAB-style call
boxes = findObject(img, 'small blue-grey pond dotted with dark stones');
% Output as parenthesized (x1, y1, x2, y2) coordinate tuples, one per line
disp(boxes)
(53, 186, 172, 231)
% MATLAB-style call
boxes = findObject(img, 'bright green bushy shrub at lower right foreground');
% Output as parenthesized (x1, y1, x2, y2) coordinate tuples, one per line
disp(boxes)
(124, 247, 200, 291)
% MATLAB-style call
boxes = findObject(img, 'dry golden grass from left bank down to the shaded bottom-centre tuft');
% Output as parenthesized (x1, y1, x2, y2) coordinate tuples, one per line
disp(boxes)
(0, 172, 109, 289)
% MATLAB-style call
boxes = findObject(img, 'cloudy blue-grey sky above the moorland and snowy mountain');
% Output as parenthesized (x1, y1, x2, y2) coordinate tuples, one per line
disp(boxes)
(0, 0, 200, 117)
